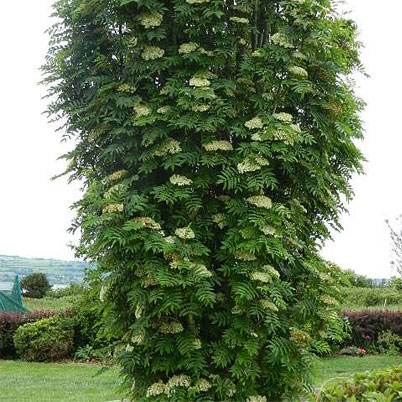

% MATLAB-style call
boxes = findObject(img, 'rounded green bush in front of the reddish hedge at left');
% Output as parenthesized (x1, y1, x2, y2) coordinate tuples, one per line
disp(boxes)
(14, 316, 74, 362)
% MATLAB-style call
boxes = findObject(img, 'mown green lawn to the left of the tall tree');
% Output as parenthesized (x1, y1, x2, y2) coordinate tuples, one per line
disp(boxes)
(0, 360, 119, 402)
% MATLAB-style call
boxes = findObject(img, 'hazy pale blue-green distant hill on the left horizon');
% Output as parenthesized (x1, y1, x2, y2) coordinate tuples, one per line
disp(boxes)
(0, 255, 89, 285)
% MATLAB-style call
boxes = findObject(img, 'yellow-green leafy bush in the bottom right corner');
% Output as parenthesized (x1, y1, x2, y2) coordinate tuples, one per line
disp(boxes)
(311, 366, 402, 402)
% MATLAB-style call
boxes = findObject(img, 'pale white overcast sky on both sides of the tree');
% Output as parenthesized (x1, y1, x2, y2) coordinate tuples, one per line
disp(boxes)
(0, 0, 402, 278)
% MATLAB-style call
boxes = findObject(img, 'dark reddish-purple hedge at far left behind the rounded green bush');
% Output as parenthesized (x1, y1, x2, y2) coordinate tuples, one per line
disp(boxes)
(0, 311, 54, 359)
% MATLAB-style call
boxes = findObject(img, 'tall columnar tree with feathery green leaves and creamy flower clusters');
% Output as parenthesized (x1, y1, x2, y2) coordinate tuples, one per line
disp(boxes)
(44, 0, 363, 401)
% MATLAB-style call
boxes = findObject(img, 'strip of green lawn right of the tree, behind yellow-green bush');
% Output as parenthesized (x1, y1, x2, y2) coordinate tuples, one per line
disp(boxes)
(314, 355, 402, 387)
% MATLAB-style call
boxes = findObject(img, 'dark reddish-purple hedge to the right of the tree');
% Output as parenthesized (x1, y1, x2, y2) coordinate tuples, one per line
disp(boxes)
(344, 310, 402, 347)
